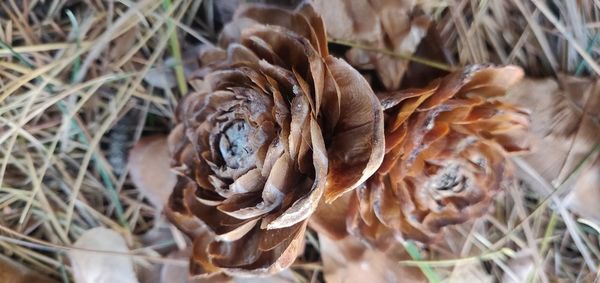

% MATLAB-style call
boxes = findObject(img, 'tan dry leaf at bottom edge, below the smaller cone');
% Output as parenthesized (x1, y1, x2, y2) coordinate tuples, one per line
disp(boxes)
(319, 235, 427, 283)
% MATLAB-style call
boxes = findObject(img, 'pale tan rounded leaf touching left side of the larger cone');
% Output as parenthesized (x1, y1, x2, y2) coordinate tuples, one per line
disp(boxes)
(128, 136, 176, 210)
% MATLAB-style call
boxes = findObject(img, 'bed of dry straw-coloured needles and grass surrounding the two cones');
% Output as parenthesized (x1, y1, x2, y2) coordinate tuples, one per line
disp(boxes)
(0, 0, 600, 282)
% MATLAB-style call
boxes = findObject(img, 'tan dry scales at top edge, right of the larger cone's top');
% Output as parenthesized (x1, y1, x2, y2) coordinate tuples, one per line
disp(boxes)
(313, 0, 430, 90)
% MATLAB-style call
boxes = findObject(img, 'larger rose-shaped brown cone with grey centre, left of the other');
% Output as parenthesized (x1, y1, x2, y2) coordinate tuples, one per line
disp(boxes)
(167, 2, 384, 275)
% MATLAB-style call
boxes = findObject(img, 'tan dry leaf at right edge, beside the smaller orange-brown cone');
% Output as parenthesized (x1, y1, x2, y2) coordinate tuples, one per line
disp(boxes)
(507, 76, 600, 221)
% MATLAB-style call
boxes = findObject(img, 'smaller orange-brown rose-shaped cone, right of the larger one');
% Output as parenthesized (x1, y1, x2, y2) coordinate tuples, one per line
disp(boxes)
(347, 65, 529, 244)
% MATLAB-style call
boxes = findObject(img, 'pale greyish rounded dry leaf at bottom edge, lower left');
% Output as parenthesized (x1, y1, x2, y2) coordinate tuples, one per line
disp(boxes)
(69, 227, 138, 283)
